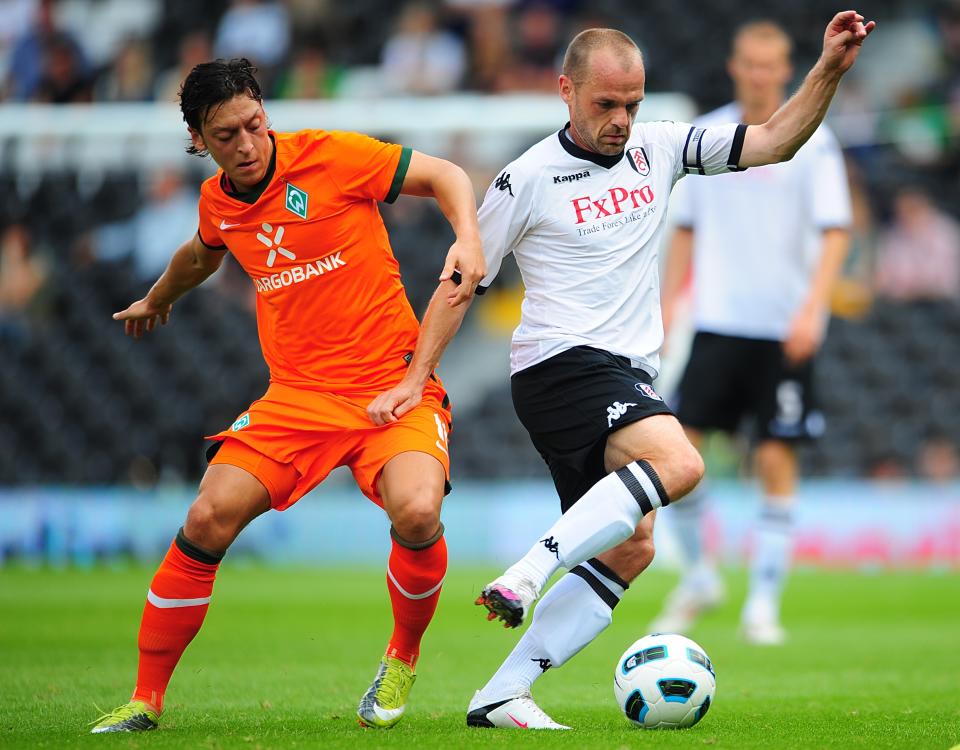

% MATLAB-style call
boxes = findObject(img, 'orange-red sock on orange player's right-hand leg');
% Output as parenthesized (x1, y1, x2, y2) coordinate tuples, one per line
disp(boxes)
(387, 526, 447, 667)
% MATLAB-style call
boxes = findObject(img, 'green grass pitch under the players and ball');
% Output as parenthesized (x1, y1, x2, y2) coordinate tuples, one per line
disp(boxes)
(0, 558, 960, 750)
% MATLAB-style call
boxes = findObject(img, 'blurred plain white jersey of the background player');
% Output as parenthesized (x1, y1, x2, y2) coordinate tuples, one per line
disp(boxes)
(673, 104, 850, 341)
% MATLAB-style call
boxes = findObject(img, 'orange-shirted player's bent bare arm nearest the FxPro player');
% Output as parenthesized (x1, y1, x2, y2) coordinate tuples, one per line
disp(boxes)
(400, 151, 487, 306)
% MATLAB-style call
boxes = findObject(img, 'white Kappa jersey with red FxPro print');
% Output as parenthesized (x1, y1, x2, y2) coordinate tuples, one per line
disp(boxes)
(478, 122, 746, 377)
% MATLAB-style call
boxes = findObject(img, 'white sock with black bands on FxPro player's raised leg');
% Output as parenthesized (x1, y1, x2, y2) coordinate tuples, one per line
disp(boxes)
(507, 460, 670, 591)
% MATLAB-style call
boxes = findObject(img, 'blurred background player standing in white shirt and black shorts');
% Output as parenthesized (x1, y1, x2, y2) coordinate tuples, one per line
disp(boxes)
(651, 22, 850, 644)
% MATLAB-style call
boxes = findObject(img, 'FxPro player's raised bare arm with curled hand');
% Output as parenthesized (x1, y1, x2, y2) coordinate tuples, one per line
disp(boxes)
(739, 10, 877, 167)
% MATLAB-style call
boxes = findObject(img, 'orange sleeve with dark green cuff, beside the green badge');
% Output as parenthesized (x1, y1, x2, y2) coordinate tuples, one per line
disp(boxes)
(328, 132, 413, 203)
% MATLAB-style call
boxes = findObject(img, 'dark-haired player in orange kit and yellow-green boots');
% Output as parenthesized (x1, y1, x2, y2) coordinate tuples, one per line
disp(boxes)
(93, 59, 485, 733)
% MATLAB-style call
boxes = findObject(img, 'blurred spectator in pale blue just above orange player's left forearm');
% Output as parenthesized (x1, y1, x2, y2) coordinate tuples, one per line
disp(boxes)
(92, 169, 200, 282)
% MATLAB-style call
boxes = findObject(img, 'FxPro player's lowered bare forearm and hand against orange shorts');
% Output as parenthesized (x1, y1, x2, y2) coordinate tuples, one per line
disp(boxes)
(367, 279, 473, 425)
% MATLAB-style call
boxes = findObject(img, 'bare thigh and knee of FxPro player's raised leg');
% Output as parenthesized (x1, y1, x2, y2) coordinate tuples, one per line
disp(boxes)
(603, 414, 704, 500)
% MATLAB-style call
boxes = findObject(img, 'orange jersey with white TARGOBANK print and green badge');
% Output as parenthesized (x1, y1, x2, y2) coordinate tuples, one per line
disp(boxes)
(200, 130, 419, 393)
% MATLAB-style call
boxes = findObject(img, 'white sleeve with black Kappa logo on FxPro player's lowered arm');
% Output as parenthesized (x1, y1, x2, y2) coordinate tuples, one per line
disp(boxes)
(477, 163, 534, 294)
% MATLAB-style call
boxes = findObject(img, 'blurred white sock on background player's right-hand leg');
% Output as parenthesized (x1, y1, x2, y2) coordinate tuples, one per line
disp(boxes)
(744, 498, 793, 621)
